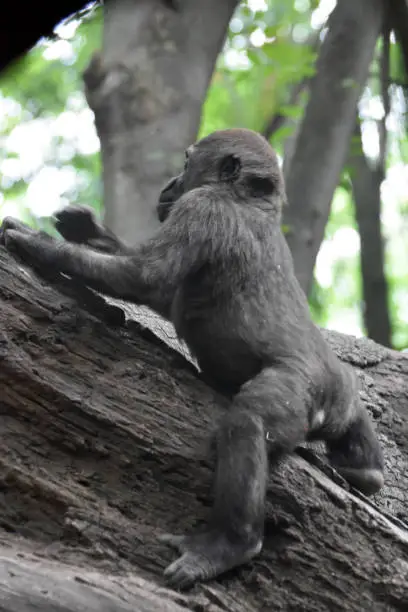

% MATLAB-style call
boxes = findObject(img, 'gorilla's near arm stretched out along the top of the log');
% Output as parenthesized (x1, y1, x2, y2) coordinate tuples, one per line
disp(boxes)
(0, 197, 206, 317)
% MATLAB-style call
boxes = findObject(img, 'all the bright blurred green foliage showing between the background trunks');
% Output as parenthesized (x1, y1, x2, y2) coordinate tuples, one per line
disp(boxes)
(0, 0, 408, 348)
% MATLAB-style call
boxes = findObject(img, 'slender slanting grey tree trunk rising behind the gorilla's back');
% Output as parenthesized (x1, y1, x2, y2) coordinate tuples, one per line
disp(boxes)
(284, 0, 384, 291)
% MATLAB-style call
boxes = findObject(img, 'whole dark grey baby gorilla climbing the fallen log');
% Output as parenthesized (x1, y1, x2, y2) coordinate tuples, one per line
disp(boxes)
(0, 129, 383, 587)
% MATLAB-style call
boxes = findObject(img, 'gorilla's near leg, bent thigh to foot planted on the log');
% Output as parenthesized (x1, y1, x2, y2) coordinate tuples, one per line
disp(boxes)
(161, 369, 307, 588)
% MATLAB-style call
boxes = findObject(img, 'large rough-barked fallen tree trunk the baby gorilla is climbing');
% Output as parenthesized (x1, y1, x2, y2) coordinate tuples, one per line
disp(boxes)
(0, 249, 408, 612)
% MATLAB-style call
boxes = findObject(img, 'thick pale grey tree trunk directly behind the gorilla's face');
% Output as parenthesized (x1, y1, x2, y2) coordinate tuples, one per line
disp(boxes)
(85, 0, 238, 244)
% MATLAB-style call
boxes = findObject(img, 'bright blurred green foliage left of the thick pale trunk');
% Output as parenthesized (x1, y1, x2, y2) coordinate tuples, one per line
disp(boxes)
(0, 6, 102, 230)
